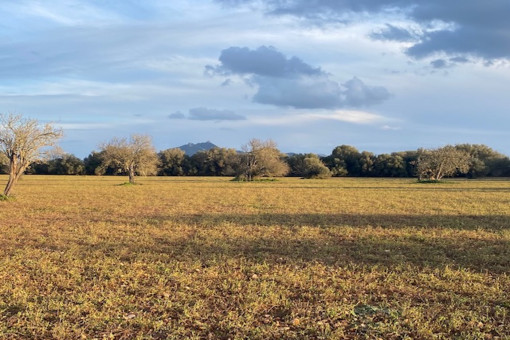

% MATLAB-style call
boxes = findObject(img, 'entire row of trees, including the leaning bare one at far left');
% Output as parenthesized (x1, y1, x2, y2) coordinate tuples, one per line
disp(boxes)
(0, 115, 510, 196)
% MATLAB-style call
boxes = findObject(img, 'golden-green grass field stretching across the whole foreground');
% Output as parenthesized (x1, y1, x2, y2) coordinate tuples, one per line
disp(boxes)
(0, 176, 510, 339)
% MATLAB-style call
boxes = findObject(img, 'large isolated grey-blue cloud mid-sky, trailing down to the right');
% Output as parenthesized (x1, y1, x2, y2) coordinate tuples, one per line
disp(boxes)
(206, 46, 390, 109)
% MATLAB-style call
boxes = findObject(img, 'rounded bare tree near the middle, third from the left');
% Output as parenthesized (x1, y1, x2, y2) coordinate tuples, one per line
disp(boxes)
(237, 139, 289, 181)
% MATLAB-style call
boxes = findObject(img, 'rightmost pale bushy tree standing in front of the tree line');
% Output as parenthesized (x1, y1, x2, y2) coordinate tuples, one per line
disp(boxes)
(417, 145, 471, 181)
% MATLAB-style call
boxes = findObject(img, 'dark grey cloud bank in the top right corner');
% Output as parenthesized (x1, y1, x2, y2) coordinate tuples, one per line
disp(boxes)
(217, 0, 510, 64)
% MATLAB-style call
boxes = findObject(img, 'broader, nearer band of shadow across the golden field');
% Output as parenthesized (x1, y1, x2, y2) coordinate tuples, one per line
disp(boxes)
(147, 228, 510, 273)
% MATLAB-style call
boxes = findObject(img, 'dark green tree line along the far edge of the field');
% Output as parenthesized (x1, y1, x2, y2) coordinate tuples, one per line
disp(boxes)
(4, 135, 510, 180)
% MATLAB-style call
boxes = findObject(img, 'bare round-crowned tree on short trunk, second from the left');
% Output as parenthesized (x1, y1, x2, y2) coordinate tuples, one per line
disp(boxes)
(101, 135, 158, 184)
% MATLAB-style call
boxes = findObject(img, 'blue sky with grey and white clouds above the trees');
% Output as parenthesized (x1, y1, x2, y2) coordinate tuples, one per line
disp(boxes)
(0, 0, 510, 157)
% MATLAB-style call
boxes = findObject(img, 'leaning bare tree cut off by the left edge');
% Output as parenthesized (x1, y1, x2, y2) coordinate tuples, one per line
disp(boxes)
(0, 114, 62, 196)
